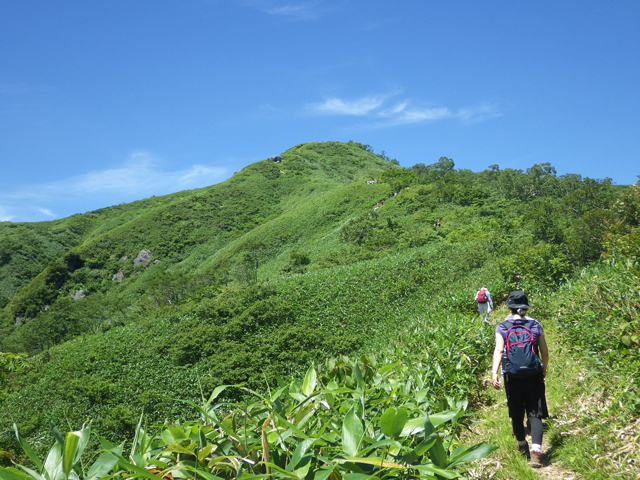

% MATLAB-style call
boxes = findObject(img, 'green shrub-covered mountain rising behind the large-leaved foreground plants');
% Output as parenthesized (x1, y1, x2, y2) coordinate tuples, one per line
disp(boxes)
(0, 142, 640, 478)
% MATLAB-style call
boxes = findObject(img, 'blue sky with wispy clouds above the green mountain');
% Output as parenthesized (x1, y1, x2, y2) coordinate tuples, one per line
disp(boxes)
(0, 0, 640, 222)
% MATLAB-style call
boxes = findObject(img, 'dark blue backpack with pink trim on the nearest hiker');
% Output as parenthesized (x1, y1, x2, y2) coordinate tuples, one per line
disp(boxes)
(501, 320, 543, 378)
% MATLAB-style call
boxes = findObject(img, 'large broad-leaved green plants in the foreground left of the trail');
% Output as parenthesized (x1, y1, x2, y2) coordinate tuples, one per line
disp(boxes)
(0, 357, 497, 480)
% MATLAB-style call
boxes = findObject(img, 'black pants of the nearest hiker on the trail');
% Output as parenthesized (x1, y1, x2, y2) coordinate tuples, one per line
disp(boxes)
(504, 374, 549, 445)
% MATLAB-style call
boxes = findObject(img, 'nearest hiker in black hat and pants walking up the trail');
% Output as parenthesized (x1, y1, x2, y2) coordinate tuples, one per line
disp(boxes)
(491, 290, 549, 468)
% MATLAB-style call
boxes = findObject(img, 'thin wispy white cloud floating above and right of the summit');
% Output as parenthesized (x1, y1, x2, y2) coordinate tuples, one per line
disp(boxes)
(307, 95, 500, 127)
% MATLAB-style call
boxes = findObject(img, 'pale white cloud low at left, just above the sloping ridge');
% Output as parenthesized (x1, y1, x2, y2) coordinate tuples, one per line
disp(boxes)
(0, 151, 229, 221)
